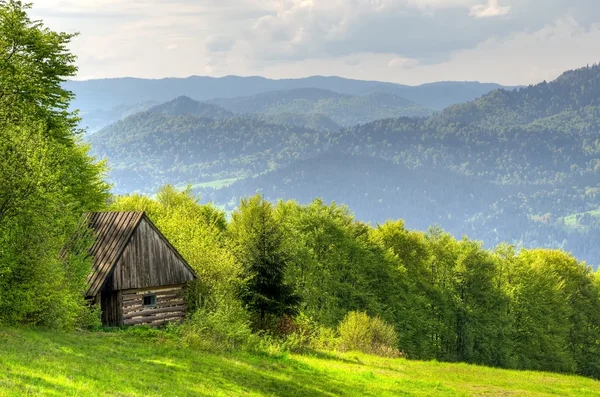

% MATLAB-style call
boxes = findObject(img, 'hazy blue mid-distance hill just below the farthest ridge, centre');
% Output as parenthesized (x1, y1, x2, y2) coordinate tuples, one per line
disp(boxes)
(211, 88, 433, 127)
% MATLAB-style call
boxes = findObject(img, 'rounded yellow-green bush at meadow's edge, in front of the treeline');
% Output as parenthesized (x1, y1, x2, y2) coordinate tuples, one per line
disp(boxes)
(338, 312, 402, 357)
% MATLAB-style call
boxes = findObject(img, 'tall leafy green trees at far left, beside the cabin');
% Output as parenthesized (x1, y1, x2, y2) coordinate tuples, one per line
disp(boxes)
(0, 0, 108, 328)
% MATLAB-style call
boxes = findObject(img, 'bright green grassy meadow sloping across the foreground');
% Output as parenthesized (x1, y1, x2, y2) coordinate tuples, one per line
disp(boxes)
(0, 329, 600, 397)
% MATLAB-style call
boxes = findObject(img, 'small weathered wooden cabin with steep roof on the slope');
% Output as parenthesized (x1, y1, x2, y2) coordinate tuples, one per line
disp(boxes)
(86, 212, 197, 326)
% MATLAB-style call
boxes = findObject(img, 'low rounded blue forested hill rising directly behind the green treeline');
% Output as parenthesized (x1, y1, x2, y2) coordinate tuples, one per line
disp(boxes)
(207, 153, 502, 231)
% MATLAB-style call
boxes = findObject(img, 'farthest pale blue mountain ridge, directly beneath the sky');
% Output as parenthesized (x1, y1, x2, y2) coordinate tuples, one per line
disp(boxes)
(65, 76, 508, 111)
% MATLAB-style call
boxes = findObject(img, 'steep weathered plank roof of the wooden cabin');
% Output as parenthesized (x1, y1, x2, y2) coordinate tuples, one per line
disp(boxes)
(85, 212, 196, 297)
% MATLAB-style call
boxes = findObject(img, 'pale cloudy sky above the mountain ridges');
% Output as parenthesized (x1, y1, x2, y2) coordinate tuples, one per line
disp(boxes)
(31, 0, 600, 85)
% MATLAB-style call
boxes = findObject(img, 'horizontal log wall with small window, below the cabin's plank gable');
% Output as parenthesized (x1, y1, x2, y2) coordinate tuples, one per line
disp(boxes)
(120, 284, 187, 327)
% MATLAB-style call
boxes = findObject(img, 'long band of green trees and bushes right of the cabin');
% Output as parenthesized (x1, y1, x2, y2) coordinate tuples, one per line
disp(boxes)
(105, 186, 600, 377)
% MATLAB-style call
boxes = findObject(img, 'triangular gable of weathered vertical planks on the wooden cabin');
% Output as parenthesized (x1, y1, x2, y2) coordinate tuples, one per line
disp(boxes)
(108, 217, 194, 290)
